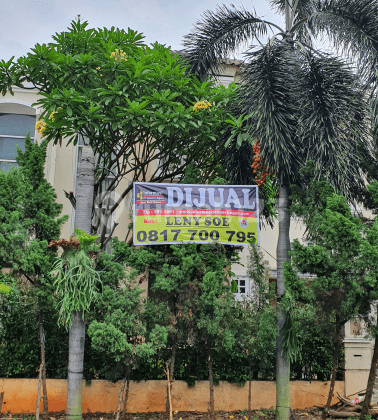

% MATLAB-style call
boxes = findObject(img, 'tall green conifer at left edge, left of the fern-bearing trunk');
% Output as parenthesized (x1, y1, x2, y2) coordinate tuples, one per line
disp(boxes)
(0, 134, 67, 376)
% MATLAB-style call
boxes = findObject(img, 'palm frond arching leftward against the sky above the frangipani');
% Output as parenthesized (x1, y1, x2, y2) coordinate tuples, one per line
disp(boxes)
(183, 5, 280, 78)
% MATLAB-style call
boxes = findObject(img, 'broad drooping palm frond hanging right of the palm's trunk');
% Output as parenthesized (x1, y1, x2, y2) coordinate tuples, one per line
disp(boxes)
(297, 53, 372, 198)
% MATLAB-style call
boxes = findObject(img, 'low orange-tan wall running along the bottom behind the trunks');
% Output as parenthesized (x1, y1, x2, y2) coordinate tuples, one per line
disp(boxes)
(0, 379, 344, 413)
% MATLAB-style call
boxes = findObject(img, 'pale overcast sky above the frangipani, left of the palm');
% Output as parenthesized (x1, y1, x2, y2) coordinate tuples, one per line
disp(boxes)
(0, 0, 281, 59)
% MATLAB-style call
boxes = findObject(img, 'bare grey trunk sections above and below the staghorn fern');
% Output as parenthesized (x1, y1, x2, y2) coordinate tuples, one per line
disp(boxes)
(66, 146, 95, 420)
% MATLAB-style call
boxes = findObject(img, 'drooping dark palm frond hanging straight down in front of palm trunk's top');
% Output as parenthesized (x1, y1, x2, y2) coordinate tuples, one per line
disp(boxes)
(240, 41, 303, 184)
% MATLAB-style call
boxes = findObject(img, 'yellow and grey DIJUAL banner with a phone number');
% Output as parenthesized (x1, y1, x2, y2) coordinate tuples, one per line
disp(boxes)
(134, 182, 259, 245)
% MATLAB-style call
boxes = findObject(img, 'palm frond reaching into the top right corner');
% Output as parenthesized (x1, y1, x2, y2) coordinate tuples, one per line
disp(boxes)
(311, 0, 378, 93)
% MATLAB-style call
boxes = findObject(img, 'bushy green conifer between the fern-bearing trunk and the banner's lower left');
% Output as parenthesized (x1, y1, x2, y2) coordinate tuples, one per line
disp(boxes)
(88, 239, 167, 381)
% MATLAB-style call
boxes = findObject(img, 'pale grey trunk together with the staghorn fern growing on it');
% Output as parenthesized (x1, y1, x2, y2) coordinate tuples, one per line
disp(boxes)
(49, 146, 100, 420)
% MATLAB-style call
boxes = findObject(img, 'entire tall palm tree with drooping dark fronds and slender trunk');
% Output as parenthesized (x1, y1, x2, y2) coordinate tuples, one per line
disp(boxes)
(184, 0, 378, 420)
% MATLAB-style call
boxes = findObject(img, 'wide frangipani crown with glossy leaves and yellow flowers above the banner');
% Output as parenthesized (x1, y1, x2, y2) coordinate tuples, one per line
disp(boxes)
(0, 21, 237, 242)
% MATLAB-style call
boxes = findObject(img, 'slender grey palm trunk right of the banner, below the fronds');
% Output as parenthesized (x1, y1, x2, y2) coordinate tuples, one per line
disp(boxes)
(276, 184, 290, 420)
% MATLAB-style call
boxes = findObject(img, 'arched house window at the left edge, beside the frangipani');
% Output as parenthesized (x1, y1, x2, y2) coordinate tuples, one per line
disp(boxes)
(0, 111, 36, 170)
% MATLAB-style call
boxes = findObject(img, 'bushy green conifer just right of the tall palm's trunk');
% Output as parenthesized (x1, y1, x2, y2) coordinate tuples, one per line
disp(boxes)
(284, 165, 378, 378)
